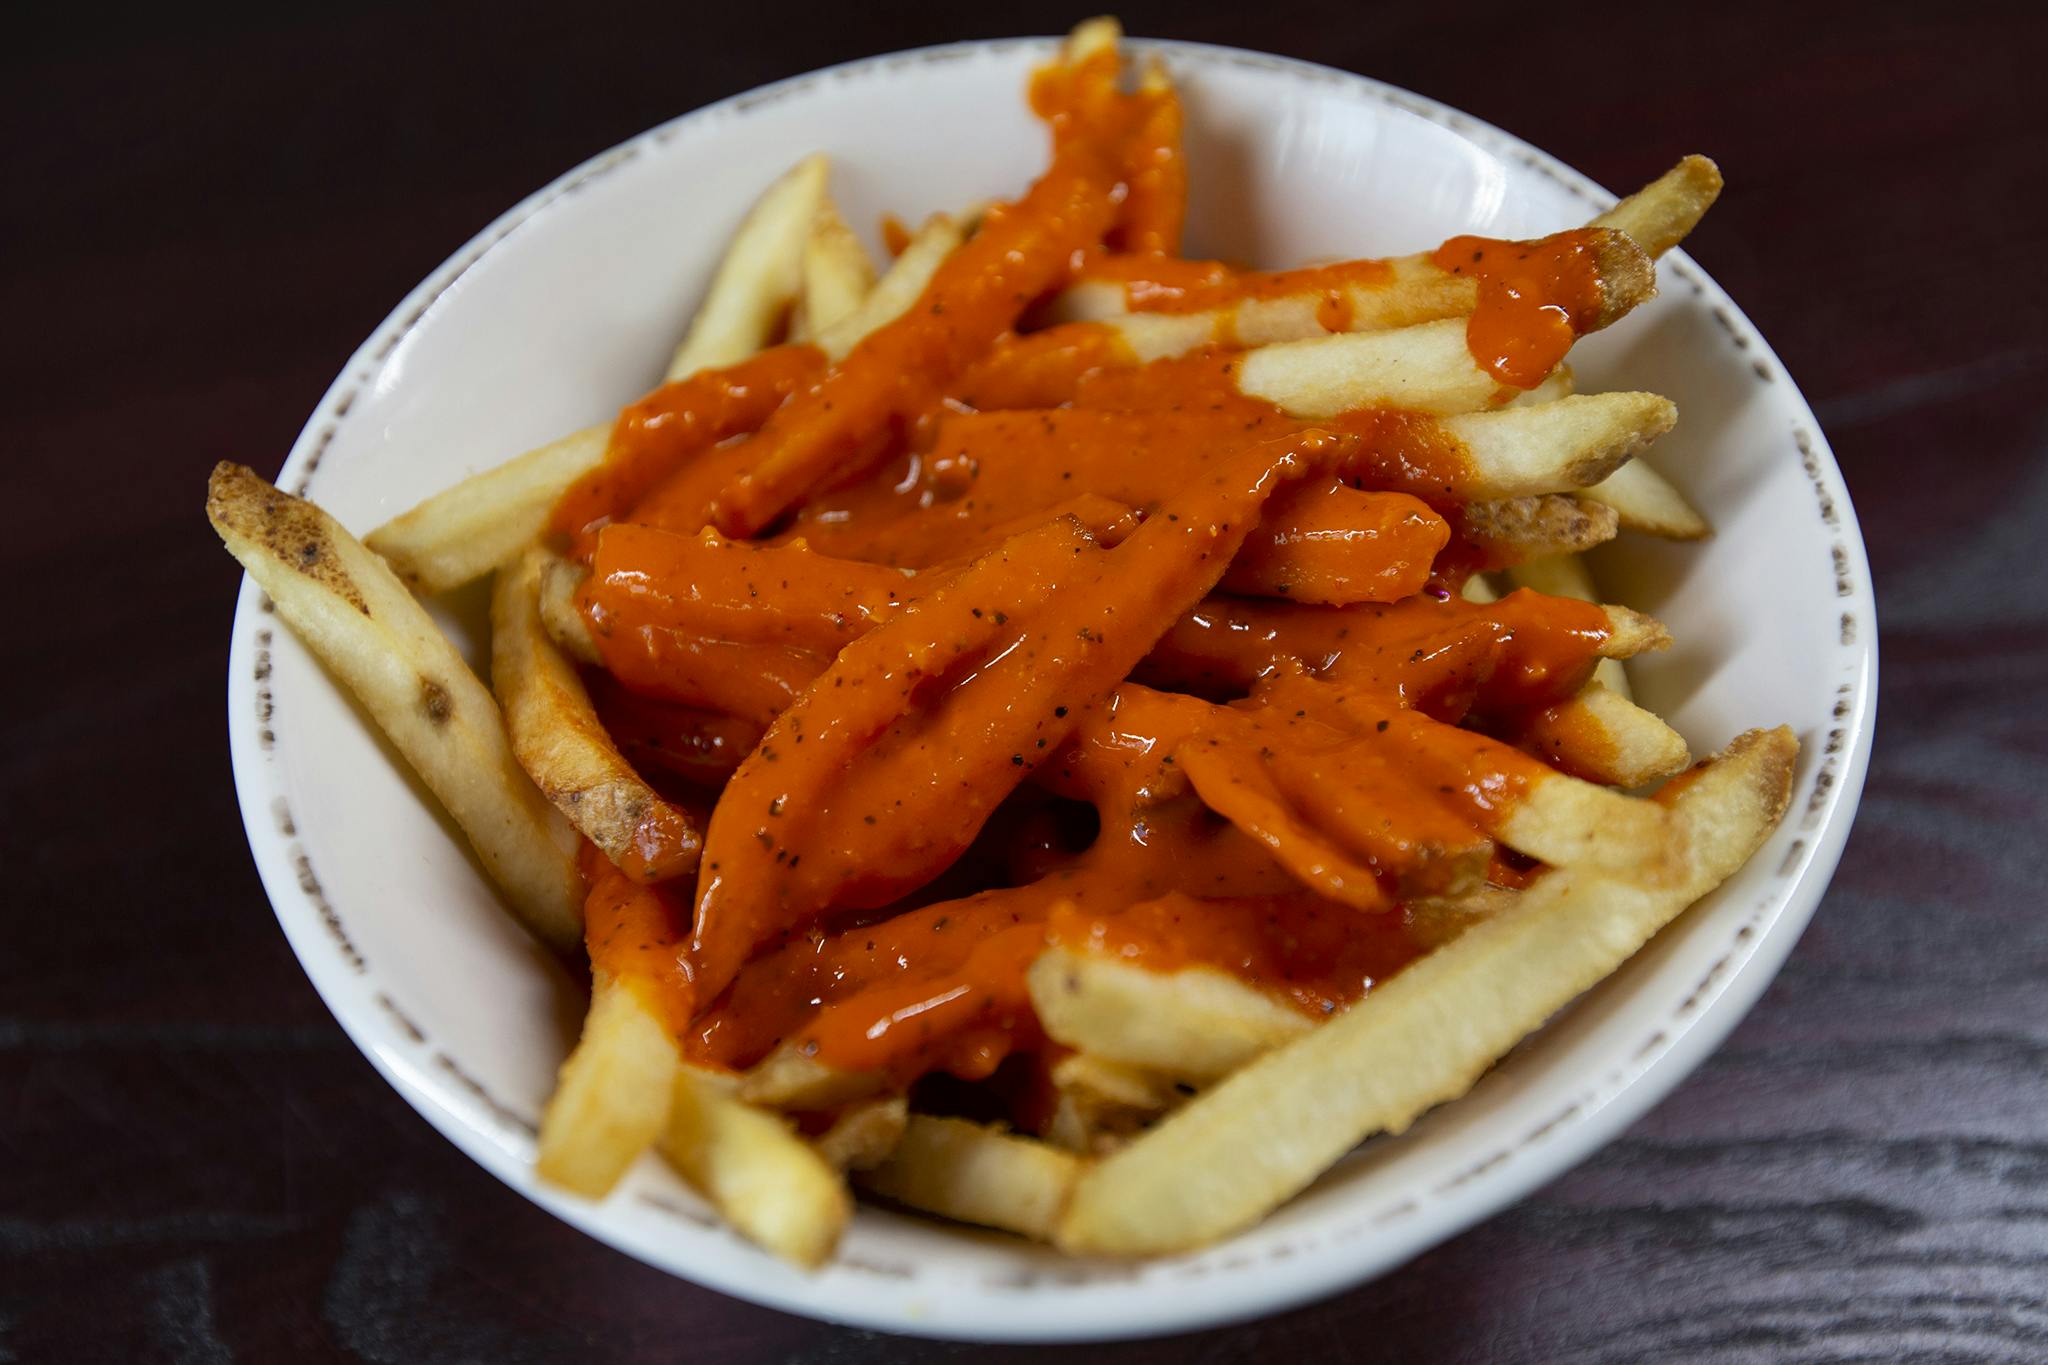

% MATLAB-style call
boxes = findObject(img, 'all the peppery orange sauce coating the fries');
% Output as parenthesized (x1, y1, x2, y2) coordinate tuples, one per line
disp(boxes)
(553, 42, 1608, 1113)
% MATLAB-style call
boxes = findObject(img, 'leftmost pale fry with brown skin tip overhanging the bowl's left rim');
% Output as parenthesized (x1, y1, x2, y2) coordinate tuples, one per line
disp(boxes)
(207, 463, 584, 952)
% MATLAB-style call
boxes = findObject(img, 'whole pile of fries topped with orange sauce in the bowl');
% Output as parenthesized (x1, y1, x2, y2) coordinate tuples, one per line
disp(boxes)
(207, 20, 1796, 1265)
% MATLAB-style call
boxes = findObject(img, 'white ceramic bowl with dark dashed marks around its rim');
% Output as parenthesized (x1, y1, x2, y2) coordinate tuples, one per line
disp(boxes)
(227, 41, 1876, 1340)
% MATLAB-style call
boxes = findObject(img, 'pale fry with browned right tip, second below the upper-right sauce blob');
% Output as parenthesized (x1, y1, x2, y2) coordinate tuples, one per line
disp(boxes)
(1440, 393, 1677, 501)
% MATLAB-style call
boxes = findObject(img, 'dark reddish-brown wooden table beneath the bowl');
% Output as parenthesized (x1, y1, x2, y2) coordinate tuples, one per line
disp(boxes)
(0, 2, 2048, 1363)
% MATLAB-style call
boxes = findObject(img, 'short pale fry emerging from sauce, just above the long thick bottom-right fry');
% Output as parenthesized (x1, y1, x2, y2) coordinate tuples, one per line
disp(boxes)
(1026, 948, 1313, 1085)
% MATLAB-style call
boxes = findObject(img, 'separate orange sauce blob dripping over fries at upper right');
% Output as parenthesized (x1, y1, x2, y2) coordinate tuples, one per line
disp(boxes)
(1430, 229, 1604, 389)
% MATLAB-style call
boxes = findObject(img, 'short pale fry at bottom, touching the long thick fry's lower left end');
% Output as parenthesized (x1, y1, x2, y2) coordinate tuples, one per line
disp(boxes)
(856, 1113, 1081, 1240)
